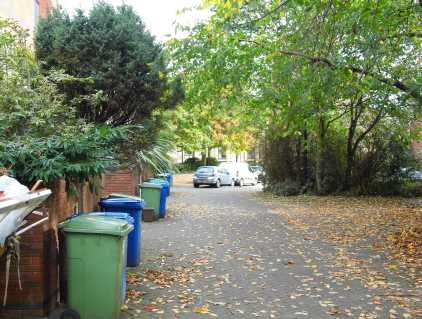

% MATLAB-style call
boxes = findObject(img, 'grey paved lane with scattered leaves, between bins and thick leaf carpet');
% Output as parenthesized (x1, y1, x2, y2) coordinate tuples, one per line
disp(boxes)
(122, 184, 415, 319)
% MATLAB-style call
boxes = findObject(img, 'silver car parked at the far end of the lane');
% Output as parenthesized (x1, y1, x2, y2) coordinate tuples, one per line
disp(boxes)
(192, 166, 234, 188)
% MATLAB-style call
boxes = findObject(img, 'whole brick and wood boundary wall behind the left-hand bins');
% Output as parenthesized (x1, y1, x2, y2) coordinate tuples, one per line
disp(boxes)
(0, 169, 145, 318)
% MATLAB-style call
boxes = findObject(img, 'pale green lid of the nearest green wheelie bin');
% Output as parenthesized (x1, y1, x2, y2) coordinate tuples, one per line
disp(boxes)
(59, 214, 133, 237)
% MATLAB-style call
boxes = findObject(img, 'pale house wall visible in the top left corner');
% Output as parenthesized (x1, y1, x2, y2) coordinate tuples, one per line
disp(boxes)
(0, 0, 58, 42)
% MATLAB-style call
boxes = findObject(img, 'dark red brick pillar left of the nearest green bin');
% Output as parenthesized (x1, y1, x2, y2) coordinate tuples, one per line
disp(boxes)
(0, 214, 58, 318)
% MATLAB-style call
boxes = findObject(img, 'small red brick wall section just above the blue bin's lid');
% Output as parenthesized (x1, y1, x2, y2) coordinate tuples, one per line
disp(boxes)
(101, 169, 139, 197)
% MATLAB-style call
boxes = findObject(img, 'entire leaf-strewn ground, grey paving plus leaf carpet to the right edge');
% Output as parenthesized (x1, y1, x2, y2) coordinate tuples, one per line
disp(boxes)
(123, 176, 422, 319)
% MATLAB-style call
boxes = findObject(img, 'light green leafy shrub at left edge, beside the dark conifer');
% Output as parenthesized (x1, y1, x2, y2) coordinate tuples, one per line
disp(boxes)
(0, 20, 74, 141)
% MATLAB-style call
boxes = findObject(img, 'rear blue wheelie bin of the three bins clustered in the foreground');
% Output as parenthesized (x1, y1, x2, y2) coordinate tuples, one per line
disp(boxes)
(99, 197, 144, 267)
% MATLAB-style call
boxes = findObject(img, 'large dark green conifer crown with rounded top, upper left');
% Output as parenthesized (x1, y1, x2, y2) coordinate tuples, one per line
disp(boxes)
(35, 2, 183, 126)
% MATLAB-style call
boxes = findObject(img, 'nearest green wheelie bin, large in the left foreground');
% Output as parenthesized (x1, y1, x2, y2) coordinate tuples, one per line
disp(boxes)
(59, 215, 133, 319)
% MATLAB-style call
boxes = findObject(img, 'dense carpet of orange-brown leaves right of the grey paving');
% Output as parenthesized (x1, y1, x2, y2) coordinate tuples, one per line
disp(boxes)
(259, 194, 422, 318)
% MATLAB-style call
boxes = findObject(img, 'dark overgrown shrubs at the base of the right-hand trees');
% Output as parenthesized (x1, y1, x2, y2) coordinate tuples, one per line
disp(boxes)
(264, 136, 422, 197)
